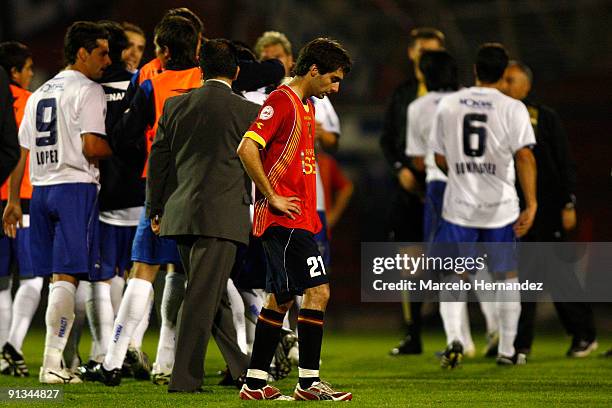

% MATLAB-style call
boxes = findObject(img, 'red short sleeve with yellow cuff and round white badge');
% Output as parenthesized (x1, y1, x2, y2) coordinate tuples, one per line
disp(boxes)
(244, 91, 295, 147)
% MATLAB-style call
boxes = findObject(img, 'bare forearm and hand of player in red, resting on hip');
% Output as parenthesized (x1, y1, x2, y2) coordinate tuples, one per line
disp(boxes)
(236, 137, 302, 220)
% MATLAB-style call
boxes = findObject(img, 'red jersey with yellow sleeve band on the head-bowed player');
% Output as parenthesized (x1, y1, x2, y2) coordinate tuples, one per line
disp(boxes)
(244, 85, 321, 237)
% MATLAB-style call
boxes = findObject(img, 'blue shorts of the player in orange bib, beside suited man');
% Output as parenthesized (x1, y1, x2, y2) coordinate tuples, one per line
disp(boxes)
(132, 209, 181, 265)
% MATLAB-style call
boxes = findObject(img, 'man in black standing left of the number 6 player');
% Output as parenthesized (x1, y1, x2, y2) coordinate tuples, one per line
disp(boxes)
(380, 28, 444, 355)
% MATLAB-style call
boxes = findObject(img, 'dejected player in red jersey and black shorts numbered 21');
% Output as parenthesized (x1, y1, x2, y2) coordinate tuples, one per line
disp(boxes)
(238, 38, 352, 401)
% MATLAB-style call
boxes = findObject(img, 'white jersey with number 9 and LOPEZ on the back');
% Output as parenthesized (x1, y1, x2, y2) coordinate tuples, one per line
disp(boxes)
(19, 70, 106, 186)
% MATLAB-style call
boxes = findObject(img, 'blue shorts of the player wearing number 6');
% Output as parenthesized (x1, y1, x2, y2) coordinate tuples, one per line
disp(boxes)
(434, 219, 518, 273)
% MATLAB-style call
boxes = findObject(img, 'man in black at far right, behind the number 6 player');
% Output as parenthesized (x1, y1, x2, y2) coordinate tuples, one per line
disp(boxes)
(504, 61, 597, 357)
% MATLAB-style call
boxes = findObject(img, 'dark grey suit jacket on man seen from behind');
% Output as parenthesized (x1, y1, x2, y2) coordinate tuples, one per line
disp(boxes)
(147, 81, 260, 244)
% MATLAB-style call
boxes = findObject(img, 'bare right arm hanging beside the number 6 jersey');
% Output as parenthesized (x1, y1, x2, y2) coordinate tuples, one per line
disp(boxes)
(514, 147, 538, 238)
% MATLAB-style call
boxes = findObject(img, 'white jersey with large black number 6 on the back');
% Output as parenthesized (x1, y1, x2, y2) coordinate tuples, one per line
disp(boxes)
(430, 87, 535, 228)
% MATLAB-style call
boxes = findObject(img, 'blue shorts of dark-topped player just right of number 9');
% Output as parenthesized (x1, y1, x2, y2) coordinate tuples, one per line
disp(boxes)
(100, 221, 136, 277)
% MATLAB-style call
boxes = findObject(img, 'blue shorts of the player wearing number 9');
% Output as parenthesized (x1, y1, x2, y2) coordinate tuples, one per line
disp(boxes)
(30, 183, 103, 281)
